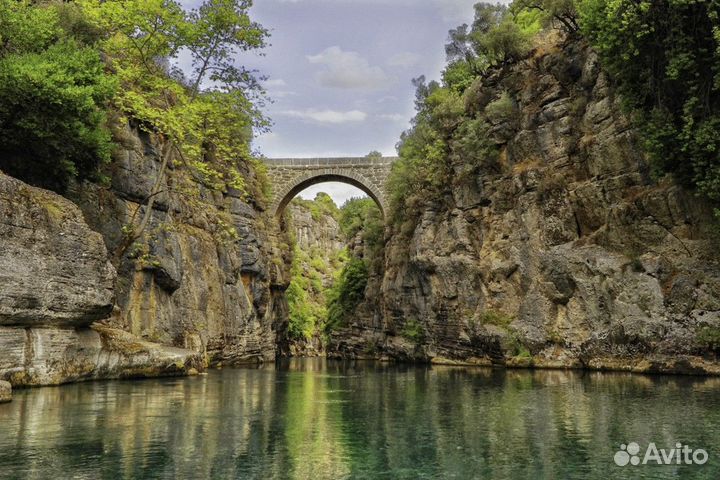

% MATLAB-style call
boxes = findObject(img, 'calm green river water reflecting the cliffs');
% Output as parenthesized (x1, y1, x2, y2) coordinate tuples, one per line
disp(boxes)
(0, 359, 720, 479)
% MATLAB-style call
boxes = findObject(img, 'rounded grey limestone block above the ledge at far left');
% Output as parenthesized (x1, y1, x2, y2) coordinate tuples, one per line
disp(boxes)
(0, 173, 115, 328)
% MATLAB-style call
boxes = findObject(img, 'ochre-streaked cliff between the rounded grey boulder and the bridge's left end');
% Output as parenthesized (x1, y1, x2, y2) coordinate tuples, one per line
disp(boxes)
(70, 125, 289, 364)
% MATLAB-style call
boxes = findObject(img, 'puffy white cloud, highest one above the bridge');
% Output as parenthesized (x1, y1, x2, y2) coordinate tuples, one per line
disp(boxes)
(307, 46, 394, 90)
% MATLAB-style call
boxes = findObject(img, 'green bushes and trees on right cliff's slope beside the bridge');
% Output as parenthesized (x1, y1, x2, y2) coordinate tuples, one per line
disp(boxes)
(388, 3, 540, 227)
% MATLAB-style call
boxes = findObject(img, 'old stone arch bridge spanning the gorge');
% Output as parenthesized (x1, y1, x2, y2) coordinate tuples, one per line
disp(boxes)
(265, 157, 397, 216)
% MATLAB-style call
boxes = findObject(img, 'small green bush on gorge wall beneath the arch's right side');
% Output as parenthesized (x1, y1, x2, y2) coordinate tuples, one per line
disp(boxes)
(327, 257, 368, 331)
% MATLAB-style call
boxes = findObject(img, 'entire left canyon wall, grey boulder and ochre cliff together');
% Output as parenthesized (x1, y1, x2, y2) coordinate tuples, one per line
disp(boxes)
(0, 124, 290, 386)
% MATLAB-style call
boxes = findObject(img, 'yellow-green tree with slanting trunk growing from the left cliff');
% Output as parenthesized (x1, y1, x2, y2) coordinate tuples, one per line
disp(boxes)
(77, 0, 268, 258)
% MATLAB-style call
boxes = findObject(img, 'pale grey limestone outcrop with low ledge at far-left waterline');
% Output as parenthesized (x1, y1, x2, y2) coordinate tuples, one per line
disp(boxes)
(0, 173, 202, 386)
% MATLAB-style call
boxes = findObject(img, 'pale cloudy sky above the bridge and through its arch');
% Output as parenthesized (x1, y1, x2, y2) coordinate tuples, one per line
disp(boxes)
(238, 0, 496, 204)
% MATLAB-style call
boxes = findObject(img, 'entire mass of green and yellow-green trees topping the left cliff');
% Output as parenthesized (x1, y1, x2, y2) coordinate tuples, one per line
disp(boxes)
(0, 0, 268, 197)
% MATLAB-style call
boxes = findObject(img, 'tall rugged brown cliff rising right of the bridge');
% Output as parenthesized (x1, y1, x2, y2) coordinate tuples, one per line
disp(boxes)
(335, 38, 720, 373)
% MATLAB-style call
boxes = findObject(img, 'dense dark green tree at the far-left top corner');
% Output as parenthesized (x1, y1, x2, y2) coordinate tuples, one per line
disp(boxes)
(0, 0, 116, 191)
